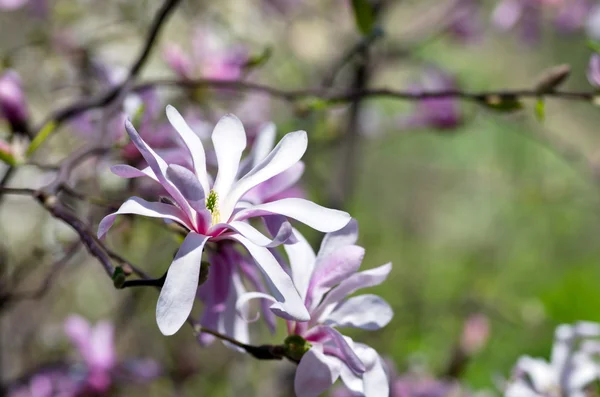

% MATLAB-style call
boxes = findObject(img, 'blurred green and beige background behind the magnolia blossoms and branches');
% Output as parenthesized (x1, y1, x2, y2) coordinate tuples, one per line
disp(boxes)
(0, 0, 600, 396)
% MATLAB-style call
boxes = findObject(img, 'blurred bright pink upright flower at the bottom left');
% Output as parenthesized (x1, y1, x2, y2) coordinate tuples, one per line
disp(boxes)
(65, 316, 117, 393)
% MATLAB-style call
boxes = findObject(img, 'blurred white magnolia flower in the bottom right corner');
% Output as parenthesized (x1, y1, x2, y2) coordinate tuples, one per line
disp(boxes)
(504, 322, 600, 397)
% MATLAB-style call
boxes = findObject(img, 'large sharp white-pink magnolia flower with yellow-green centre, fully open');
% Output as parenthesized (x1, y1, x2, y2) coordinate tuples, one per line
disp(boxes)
(98, 106, 350, 335)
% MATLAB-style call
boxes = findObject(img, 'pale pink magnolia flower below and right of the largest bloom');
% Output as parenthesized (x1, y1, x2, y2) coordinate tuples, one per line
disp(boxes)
(238, 221, 393, 397)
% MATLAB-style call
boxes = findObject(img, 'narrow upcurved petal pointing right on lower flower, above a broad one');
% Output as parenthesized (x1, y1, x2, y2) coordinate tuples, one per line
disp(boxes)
(311, 263, 392, 324)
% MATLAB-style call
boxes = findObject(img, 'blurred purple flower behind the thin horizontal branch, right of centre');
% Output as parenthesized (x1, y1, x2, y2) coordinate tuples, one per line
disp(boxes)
(399, 67, 463, 130)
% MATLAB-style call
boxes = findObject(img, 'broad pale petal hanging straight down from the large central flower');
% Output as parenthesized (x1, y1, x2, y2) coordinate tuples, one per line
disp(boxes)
(156, 232, 209, 335)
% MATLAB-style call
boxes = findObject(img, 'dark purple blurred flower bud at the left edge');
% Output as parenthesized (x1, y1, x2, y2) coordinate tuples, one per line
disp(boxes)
(0, 70, 29, 132)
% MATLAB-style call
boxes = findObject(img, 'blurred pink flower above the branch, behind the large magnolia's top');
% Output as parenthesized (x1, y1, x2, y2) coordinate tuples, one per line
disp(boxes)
(163, 29, 248, 80)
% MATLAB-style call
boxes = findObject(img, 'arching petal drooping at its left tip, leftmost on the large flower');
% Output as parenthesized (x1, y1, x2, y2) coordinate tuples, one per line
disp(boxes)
(98, 196, 192, 238)
